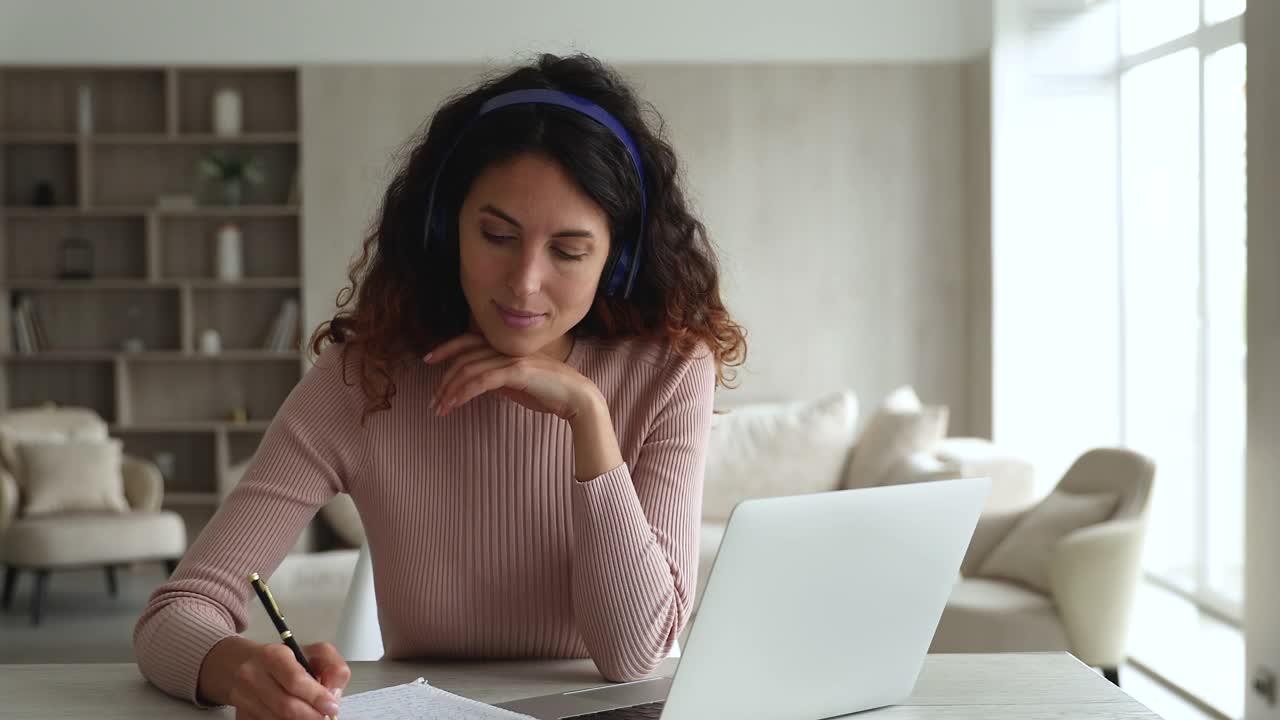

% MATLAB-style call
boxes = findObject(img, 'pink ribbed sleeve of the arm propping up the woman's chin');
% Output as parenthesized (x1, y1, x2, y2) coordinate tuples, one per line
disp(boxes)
(572, 345, 716, 682)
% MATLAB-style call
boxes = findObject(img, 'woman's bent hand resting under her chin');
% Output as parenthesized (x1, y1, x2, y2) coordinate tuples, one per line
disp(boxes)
(424, 333, 599, 420)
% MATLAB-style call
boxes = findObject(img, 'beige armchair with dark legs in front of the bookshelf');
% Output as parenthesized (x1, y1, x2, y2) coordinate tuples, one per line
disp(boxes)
(0, 407, 187, 624)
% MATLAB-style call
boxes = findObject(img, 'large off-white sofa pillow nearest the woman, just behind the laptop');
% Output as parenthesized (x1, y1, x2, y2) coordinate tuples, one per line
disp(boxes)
(703, 391, 858, 520)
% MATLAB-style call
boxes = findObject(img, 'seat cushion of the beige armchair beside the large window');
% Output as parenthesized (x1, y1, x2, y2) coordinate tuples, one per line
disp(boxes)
(929, 578, 1069, 652)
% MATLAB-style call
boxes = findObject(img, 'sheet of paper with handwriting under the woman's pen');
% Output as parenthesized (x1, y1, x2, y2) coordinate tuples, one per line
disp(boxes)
(339, 680, 534, 720)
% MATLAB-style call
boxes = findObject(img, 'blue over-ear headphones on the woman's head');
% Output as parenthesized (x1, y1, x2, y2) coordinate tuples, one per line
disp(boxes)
(422, 88, 648, 297)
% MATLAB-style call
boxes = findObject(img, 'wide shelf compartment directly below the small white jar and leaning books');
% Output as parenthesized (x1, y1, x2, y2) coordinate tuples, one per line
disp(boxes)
(127, 360, 302, 427)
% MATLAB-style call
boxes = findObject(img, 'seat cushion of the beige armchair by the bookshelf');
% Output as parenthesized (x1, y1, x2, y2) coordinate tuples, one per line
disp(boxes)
(0, 511, 187, 569)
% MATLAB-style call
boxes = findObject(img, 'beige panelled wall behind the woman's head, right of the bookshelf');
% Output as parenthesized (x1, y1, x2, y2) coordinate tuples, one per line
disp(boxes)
(302, 63, 987, 425)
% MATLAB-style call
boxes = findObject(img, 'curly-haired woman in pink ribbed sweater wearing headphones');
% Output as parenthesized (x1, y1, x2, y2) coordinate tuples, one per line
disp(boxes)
(134, 55, 746, 717)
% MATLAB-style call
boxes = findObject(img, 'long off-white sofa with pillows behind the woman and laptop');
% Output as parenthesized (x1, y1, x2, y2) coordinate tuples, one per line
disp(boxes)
(246, 392, 1033, 642)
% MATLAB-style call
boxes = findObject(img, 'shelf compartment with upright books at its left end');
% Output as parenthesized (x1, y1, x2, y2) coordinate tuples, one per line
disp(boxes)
(10, 286, 182, 351)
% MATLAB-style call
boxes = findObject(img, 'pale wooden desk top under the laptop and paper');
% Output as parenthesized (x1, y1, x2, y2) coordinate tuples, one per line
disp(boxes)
(0, 653, 1158, 720)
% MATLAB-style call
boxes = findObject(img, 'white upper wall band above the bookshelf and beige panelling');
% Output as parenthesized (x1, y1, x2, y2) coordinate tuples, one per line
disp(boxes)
(0, 0, 991, 64)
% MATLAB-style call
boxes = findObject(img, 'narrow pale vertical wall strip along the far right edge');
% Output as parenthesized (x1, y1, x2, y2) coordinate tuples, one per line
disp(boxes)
(1244, 0, 1280, 720)
